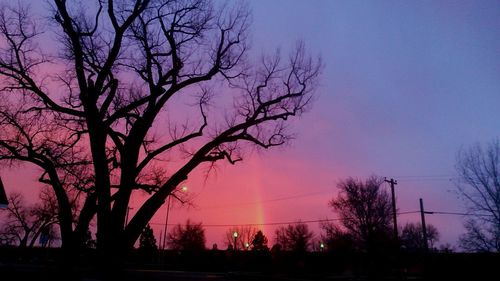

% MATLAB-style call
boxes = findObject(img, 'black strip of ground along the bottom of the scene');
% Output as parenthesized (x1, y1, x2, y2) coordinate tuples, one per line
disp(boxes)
(0, 248, 500, 281)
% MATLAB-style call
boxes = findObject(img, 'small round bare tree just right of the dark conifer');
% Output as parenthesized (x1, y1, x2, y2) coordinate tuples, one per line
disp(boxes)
(276, 222, 314, 253)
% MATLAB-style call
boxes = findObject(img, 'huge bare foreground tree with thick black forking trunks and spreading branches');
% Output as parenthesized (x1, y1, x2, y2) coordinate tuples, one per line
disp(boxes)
(0, 0, 321, 260)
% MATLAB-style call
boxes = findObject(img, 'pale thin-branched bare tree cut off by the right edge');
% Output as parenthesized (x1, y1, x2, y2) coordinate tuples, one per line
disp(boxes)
(456, 140, 500, 252)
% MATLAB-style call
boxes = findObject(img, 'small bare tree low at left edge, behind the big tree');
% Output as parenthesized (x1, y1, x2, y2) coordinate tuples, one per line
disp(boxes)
(0, 189, 59, 248)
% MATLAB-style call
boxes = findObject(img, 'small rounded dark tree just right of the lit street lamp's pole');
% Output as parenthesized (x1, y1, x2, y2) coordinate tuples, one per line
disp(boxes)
(168, 220, 206, 252)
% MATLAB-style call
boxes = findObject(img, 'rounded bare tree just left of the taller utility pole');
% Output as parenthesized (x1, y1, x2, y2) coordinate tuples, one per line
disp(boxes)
(330, 176, 392, 251)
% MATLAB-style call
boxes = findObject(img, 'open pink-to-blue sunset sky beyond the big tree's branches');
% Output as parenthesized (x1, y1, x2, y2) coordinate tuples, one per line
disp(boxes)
(2, 0, 500, 248)
